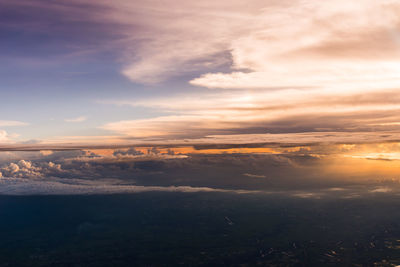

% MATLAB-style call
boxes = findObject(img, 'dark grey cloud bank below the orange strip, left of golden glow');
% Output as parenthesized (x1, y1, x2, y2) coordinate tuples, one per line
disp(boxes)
(0, 149, 340, 189)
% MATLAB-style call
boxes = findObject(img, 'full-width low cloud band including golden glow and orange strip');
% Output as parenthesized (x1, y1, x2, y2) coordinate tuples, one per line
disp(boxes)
(0, 147, 400, 196)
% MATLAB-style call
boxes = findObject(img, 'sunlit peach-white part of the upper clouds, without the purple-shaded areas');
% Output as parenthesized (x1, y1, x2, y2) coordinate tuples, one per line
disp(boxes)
(96, 0, 400, 142)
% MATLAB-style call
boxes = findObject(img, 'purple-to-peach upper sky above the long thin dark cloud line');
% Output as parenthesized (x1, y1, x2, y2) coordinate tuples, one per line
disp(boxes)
(0, 0, 400, 149)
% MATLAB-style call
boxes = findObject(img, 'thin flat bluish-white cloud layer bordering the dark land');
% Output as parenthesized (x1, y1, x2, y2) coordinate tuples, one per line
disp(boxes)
(0, 177, 399, 199)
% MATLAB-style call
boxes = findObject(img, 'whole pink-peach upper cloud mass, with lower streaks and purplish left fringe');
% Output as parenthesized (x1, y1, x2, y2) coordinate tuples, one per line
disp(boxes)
(0, 0, 400, 143)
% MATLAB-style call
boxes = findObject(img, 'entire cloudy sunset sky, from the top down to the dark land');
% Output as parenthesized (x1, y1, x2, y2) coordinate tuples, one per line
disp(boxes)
(0, 0, 400, 194)
